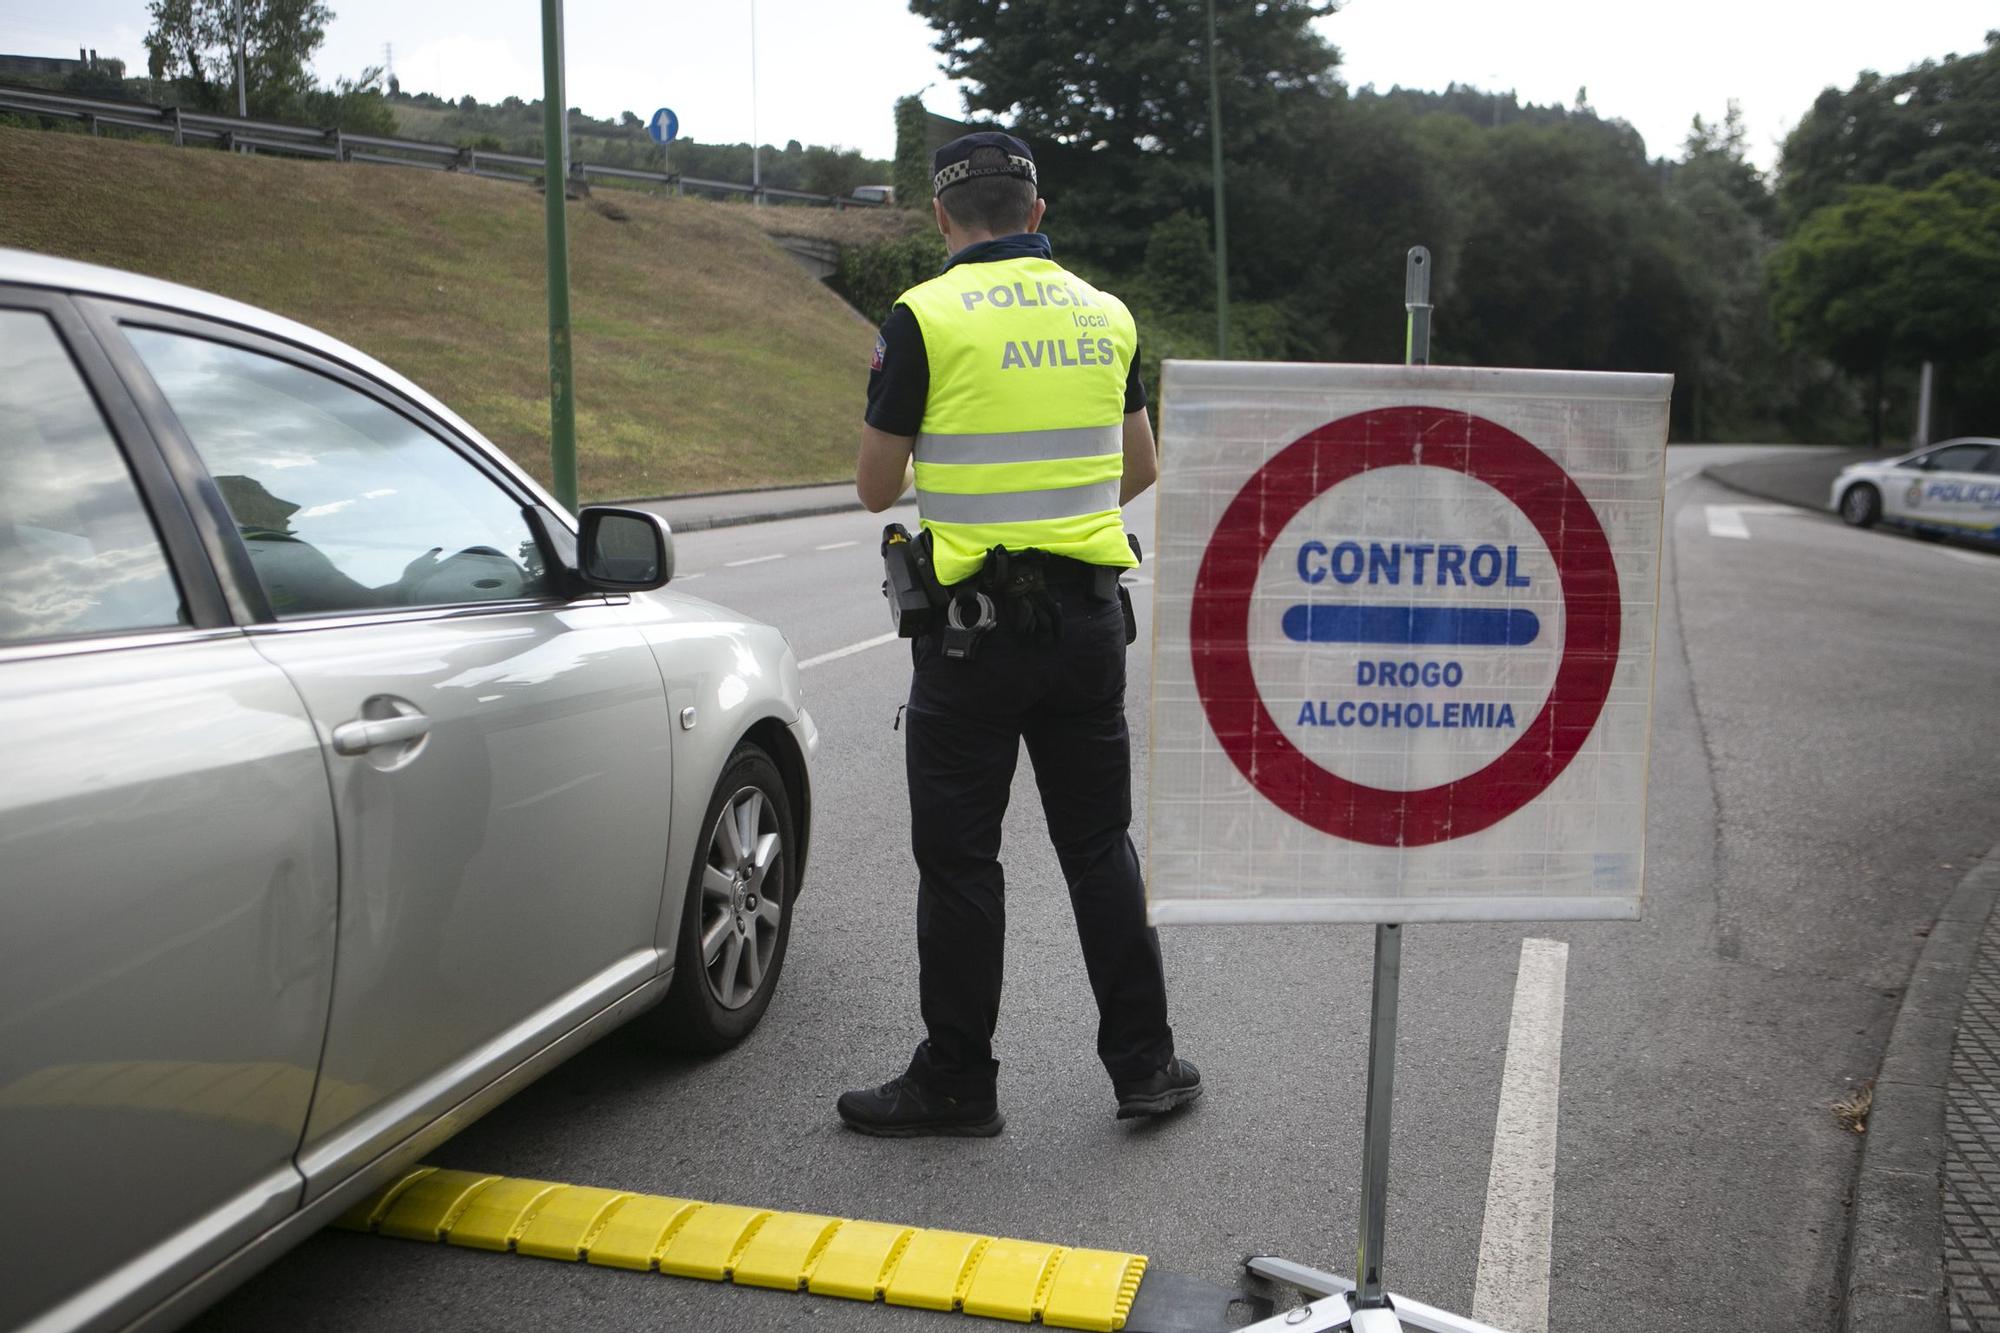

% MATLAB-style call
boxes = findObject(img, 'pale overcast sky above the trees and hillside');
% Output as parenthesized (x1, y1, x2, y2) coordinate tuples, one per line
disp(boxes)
(0, 0, 2000, 166)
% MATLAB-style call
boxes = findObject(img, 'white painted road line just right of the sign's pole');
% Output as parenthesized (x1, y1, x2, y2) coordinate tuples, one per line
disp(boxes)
(1472, 939, 1570, 1333)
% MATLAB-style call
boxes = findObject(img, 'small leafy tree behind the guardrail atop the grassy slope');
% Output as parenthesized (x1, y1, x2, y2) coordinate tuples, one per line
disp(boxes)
(146, 0, 334, 118)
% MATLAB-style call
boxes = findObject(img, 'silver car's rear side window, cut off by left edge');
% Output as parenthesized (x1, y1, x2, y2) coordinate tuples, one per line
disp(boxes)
(0, 310, 190, 644)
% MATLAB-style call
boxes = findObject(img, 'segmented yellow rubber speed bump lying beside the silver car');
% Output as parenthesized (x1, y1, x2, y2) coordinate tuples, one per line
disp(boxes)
(334, 1167, 1146, 1333)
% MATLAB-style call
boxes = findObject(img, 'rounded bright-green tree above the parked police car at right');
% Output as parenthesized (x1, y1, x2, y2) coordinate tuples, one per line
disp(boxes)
(1772, 172, 2000, 446)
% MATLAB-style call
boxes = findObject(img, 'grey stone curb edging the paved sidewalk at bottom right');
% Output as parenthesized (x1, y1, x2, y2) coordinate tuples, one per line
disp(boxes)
(1840, 844, 2000, 1333)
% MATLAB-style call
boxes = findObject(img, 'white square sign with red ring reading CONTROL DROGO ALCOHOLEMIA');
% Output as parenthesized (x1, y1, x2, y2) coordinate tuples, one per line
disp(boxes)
(1148, 362, 1672, 925)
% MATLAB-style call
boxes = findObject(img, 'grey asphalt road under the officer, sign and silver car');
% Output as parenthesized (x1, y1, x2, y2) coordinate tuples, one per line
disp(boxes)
(198, 448, 2000, 1333)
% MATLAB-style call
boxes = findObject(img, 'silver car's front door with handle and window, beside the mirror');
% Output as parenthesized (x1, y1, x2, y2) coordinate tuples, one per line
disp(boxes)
(103, 312, 670, 1201)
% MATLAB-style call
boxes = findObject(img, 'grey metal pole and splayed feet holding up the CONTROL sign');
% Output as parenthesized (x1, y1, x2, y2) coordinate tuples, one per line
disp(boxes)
(1242, 246, 1500, 1333)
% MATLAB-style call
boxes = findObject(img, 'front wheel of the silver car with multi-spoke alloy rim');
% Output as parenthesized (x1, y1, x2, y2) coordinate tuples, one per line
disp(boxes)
(652, 743, 798, 1053)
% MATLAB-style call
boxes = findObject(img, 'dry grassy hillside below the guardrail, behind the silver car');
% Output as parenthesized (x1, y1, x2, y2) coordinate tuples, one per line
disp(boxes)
(0, 128, 874, 498)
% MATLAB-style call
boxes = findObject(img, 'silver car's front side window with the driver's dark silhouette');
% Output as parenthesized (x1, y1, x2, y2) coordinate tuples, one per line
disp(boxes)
(126, 328, 554, 618)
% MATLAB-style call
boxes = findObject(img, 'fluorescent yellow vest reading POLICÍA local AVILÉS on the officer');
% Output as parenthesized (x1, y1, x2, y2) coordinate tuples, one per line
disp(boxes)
(898, 258, 1138, 582)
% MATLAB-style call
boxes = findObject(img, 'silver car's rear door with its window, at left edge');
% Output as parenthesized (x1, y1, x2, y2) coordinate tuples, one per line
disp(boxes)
(0, 288, 338, 1329)
